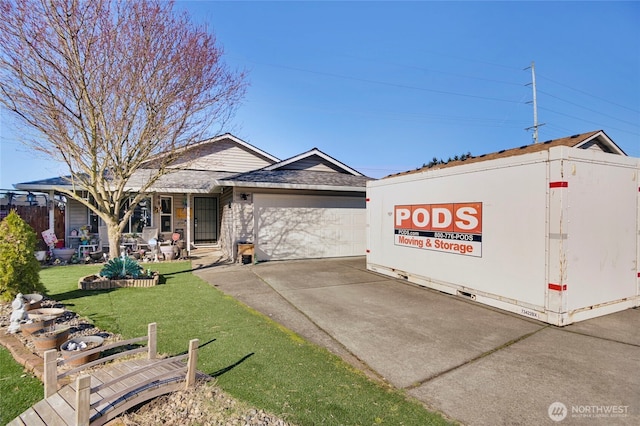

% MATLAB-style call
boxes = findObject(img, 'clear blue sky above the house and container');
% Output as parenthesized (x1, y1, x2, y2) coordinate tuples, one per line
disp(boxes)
(0, 1, 640, 189)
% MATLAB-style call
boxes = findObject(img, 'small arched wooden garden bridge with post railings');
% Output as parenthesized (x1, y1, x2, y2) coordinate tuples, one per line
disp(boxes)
(9, 323, 198, 426)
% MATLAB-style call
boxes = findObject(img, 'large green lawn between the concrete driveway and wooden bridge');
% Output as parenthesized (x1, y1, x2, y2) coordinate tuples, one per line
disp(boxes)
(12, 262, 446, 425)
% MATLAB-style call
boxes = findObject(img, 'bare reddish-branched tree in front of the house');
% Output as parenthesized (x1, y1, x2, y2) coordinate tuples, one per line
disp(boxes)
(0, 0, 246, 257)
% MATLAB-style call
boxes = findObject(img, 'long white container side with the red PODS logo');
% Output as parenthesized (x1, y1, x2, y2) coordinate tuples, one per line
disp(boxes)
(367, 159, 548, 309)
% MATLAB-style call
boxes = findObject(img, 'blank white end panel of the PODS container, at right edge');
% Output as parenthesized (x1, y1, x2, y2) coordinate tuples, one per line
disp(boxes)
(566, 161, 638, 311)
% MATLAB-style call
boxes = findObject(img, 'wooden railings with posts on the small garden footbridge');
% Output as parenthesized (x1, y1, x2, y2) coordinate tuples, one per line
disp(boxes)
(44, 323, 199, 426)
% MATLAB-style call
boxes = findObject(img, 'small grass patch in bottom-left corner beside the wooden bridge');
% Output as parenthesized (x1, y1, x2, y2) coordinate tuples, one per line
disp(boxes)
(0, 346, 44, 425)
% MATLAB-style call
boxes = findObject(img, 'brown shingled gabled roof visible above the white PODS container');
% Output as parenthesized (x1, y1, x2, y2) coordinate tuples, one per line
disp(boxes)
(387, 130, 627, 177)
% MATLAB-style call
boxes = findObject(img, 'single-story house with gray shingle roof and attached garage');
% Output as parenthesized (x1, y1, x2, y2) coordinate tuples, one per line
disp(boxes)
(14, 133, 370, 261)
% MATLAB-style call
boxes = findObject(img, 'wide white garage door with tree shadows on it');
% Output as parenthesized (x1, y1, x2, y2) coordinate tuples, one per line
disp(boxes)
(253, 194, 366, 260)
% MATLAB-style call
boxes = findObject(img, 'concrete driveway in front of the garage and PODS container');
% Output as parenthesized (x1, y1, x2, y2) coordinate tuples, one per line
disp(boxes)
(195, 257, 640, 425)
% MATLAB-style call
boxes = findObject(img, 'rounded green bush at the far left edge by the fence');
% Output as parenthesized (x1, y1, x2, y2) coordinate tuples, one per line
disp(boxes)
(0, 210, 44, 301)
